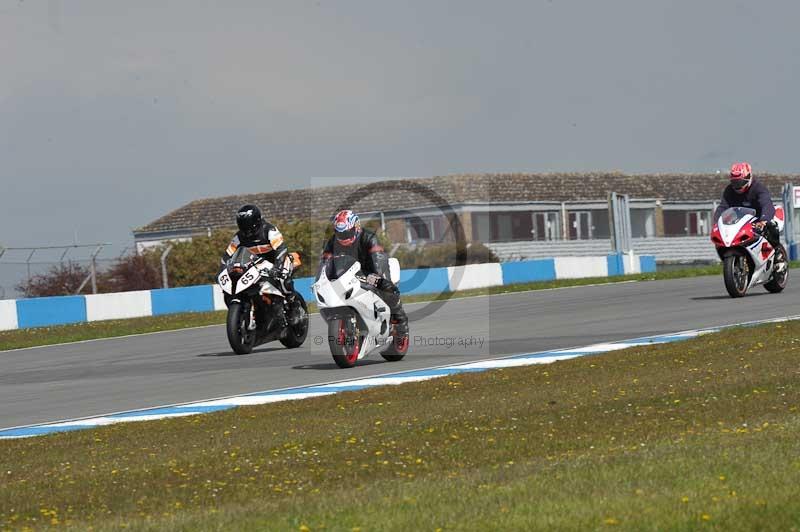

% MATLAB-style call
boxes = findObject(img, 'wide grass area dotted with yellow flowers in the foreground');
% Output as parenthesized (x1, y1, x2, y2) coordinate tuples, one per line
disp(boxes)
(0, 322, 800, 531)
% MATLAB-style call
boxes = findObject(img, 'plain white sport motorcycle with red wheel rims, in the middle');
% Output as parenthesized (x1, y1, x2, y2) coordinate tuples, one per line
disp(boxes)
(311, 255, 408, 368)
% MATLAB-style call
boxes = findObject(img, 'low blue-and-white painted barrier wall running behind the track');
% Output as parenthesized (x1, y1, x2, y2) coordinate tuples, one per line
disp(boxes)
(0, 255, 656, 330)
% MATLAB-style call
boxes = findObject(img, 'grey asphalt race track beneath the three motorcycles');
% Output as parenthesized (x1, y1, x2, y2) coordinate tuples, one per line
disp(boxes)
(0, 276, 800, 428)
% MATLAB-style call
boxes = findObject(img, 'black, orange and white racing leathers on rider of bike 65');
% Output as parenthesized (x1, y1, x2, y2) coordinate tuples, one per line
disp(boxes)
(221, 220, 294, 298)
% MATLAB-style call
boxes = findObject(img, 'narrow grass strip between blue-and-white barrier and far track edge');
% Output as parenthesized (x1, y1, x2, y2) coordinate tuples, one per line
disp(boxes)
(0, 262, 800, 351)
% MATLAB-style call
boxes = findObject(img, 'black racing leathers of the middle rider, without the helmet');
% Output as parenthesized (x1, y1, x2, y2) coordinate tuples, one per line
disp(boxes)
(319, 228, 408, 336)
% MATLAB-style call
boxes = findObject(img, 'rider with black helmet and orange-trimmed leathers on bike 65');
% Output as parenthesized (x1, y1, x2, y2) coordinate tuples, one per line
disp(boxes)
(221, 204, 294, 303)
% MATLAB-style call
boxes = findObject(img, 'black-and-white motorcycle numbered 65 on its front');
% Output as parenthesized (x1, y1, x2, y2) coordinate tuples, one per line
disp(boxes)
(217, 246, 308, 355)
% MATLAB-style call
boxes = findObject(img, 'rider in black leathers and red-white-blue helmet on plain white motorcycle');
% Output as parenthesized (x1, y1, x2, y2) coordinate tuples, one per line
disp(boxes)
(317, 210, 408, 352)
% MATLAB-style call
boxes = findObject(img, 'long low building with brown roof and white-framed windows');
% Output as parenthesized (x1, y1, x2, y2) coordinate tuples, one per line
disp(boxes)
(133, 173, 800, 254)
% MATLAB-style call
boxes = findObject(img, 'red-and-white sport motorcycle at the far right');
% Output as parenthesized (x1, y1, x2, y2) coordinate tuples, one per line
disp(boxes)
(711, 207, 789, 297)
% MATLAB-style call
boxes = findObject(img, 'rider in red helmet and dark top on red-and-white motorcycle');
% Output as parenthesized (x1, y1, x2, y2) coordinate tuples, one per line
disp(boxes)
(714, 162, 786, 271)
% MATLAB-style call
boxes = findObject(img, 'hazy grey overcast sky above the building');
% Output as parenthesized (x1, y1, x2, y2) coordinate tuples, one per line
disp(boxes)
(0, 0, 800, 290)
